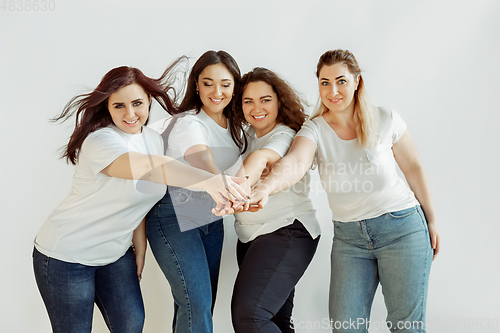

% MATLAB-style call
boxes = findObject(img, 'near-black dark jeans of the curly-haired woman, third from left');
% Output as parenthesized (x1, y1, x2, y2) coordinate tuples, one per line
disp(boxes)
(231, 220, 319, 333)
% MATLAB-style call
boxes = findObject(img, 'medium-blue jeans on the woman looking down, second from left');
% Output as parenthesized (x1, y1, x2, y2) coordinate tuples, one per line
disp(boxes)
(146, 186, 224, 333)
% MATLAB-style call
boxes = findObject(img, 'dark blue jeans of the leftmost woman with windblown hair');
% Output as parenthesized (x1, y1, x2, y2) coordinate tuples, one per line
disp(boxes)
(33, 248, 144, 333)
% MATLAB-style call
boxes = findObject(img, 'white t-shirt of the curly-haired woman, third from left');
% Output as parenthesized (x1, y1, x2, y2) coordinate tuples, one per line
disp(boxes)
(235, 124, 321, 243)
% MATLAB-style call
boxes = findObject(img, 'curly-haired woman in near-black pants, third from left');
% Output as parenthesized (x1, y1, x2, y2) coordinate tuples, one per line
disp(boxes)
(231, 67, 320, 333)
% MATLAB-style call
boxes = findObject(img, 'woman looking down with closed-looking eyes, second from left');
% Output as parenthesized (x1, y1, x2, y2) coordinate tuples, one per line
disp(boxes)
(147, 51, 244, 333)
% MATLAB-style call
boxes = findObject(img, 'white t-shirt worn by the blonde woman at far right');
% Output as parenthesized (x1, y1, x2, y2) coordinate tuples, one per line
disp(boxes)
(297, 107, 418, 222)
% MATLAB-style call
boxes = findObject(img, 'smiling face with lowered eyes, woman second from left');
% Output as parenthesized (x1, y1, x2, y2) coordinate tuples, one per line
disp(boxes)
(196, 64, 234, 118)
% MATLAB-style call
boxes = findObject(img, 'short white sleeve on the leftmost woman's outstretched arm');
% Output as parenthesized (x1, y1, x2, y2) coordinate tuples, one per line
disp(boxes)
(78, 128, 129, 176)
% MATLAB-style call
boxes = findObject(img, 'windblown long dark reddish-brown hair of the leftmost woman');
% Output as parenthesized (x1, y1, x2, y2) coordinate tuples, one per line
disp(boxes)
(51, 57, 185, 164)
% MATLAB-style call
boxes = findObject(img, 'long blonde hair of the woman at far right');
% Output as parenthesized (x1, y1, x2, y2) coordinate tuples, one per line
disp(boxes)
(311, 49, 378, 147)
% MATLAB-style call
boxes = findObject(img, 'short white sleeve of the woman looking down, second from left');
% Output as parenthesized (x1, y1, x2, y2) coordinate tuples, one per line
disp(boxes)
(168, 115, 208, 156)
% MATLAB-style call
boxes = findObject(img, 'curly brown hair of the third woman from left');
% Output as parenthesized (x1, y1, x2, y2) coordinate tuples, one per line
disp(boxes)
(234, 67, 307, 135)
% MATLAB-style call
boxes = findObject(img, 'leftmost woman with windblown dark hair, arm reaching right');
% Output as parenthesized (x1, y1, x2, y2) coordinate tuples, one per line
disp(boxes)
(33, 64, 244, 333)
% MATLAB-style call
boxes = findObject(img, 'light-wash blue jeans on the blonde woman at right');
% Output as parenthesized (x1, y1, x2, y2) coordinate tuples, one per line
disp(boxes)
(330, 206, 433, 332)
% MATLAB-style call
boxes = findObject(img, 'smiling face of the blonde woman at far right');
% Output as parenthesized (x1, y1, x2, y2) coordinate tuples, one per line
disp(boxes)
(319, 62, 359, 113)
